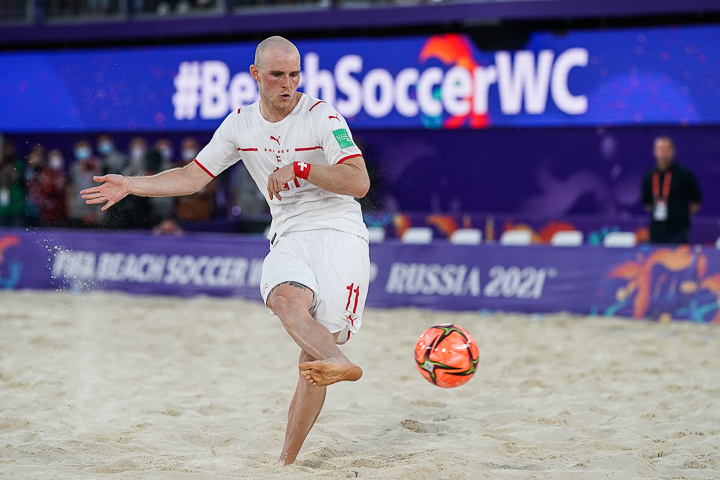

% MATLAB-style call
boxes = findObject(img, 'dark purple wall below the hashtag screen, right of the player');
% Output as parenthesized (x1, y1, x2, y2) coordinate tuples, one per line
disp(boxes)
(356, 127, 720, 217)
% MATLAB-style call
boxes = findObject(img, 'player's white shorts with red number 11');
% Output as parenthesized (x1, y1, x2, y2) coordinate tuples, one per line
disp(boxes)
(260, 229, 370, 345)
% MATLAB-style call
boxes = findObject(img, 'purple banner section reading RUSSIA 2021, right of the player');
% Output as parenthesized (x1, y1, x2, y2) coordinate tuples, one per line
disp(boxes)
(368, 242, 720, 322)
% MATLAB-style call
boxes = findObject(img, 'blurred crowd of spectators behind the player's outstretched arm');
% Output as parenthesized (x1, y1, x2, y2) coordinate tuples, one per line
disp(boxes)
(0, 134, 270, 233)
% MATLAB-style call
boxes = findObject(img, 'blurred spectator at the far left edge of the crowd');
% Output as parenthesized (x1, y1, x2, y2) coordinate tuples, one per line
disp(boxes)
(0, 142, 26, 227)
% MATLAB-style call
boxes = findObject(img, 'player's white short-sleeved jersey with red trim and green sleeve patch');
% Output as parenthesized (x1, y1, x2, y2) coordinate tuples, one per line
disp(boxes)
(195, 94, 368, 241)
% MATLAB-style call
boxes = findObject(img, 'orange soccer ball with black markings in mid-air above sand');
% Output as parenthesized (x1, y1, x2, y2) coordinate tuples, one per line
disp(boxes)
(415, 323, 480, 388)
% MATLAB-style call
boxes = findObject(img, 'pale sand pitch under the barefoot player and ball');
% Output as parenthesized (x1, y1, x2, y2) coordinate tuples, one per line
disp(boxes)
(0, 292, 720, 480)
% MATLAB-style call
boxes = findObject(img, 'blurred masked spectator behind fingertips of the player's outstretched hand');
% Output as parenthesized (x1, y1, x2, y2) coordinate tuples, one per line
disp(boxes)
(68, 140, 102, 227)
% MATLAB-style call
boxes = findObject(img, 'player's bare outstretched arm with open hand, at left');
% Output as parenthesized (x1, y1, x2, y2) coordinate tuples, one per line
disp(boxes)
(80, 162, 212, 210)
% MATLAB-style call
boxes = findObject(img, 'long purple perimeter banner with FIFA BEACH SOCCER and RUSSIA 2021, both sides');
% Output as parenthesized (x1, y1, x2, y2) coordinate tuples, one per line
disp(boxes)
(0, 230, 720, 322)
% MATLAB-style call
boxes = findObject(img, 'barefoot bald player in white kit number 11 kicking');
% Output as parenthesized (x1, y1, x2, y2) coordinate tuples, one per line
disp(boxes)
(81, 36, 370, 464)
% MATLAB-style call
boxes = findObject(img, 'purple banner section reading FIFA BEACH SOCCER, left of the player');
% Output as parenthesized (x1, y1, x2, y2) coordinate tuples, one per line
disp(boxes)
(0, 231, 268, 299)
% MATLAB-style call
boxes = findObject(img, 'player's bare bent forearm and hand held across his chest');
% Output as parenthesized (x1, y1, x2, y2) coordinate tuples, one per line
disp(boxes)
(267, 156, 370, 200)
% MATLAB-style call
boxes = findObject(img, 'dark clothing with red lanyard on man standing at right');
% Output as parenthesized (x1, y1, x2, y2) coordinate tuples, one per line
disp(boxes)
(642, 163, 702, 243)
